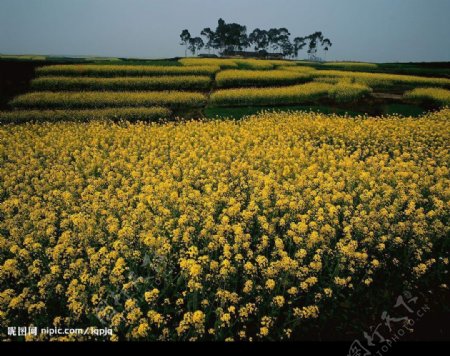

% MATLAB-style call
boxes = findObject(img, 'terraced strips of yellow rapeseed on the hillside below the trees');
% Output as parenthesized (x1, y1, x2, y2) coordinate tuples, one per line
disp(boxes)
(0, 58, 450, 122)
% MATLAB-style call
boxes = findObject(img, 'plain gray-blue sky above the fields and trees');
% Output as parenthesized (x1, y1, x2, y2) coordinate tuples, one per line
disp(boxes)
(0, 0, 450, 62)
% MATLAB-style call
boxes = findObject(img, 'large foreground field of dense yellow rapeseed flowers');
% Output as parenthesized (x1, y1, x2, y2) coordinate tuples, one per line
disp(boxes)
(0, 109, 450, 340)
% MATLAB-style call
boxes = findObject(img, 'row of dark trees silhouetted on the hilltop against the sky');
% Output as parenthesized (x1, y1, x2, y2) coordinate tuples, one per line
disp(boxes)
(180, 19, 332, 60)
